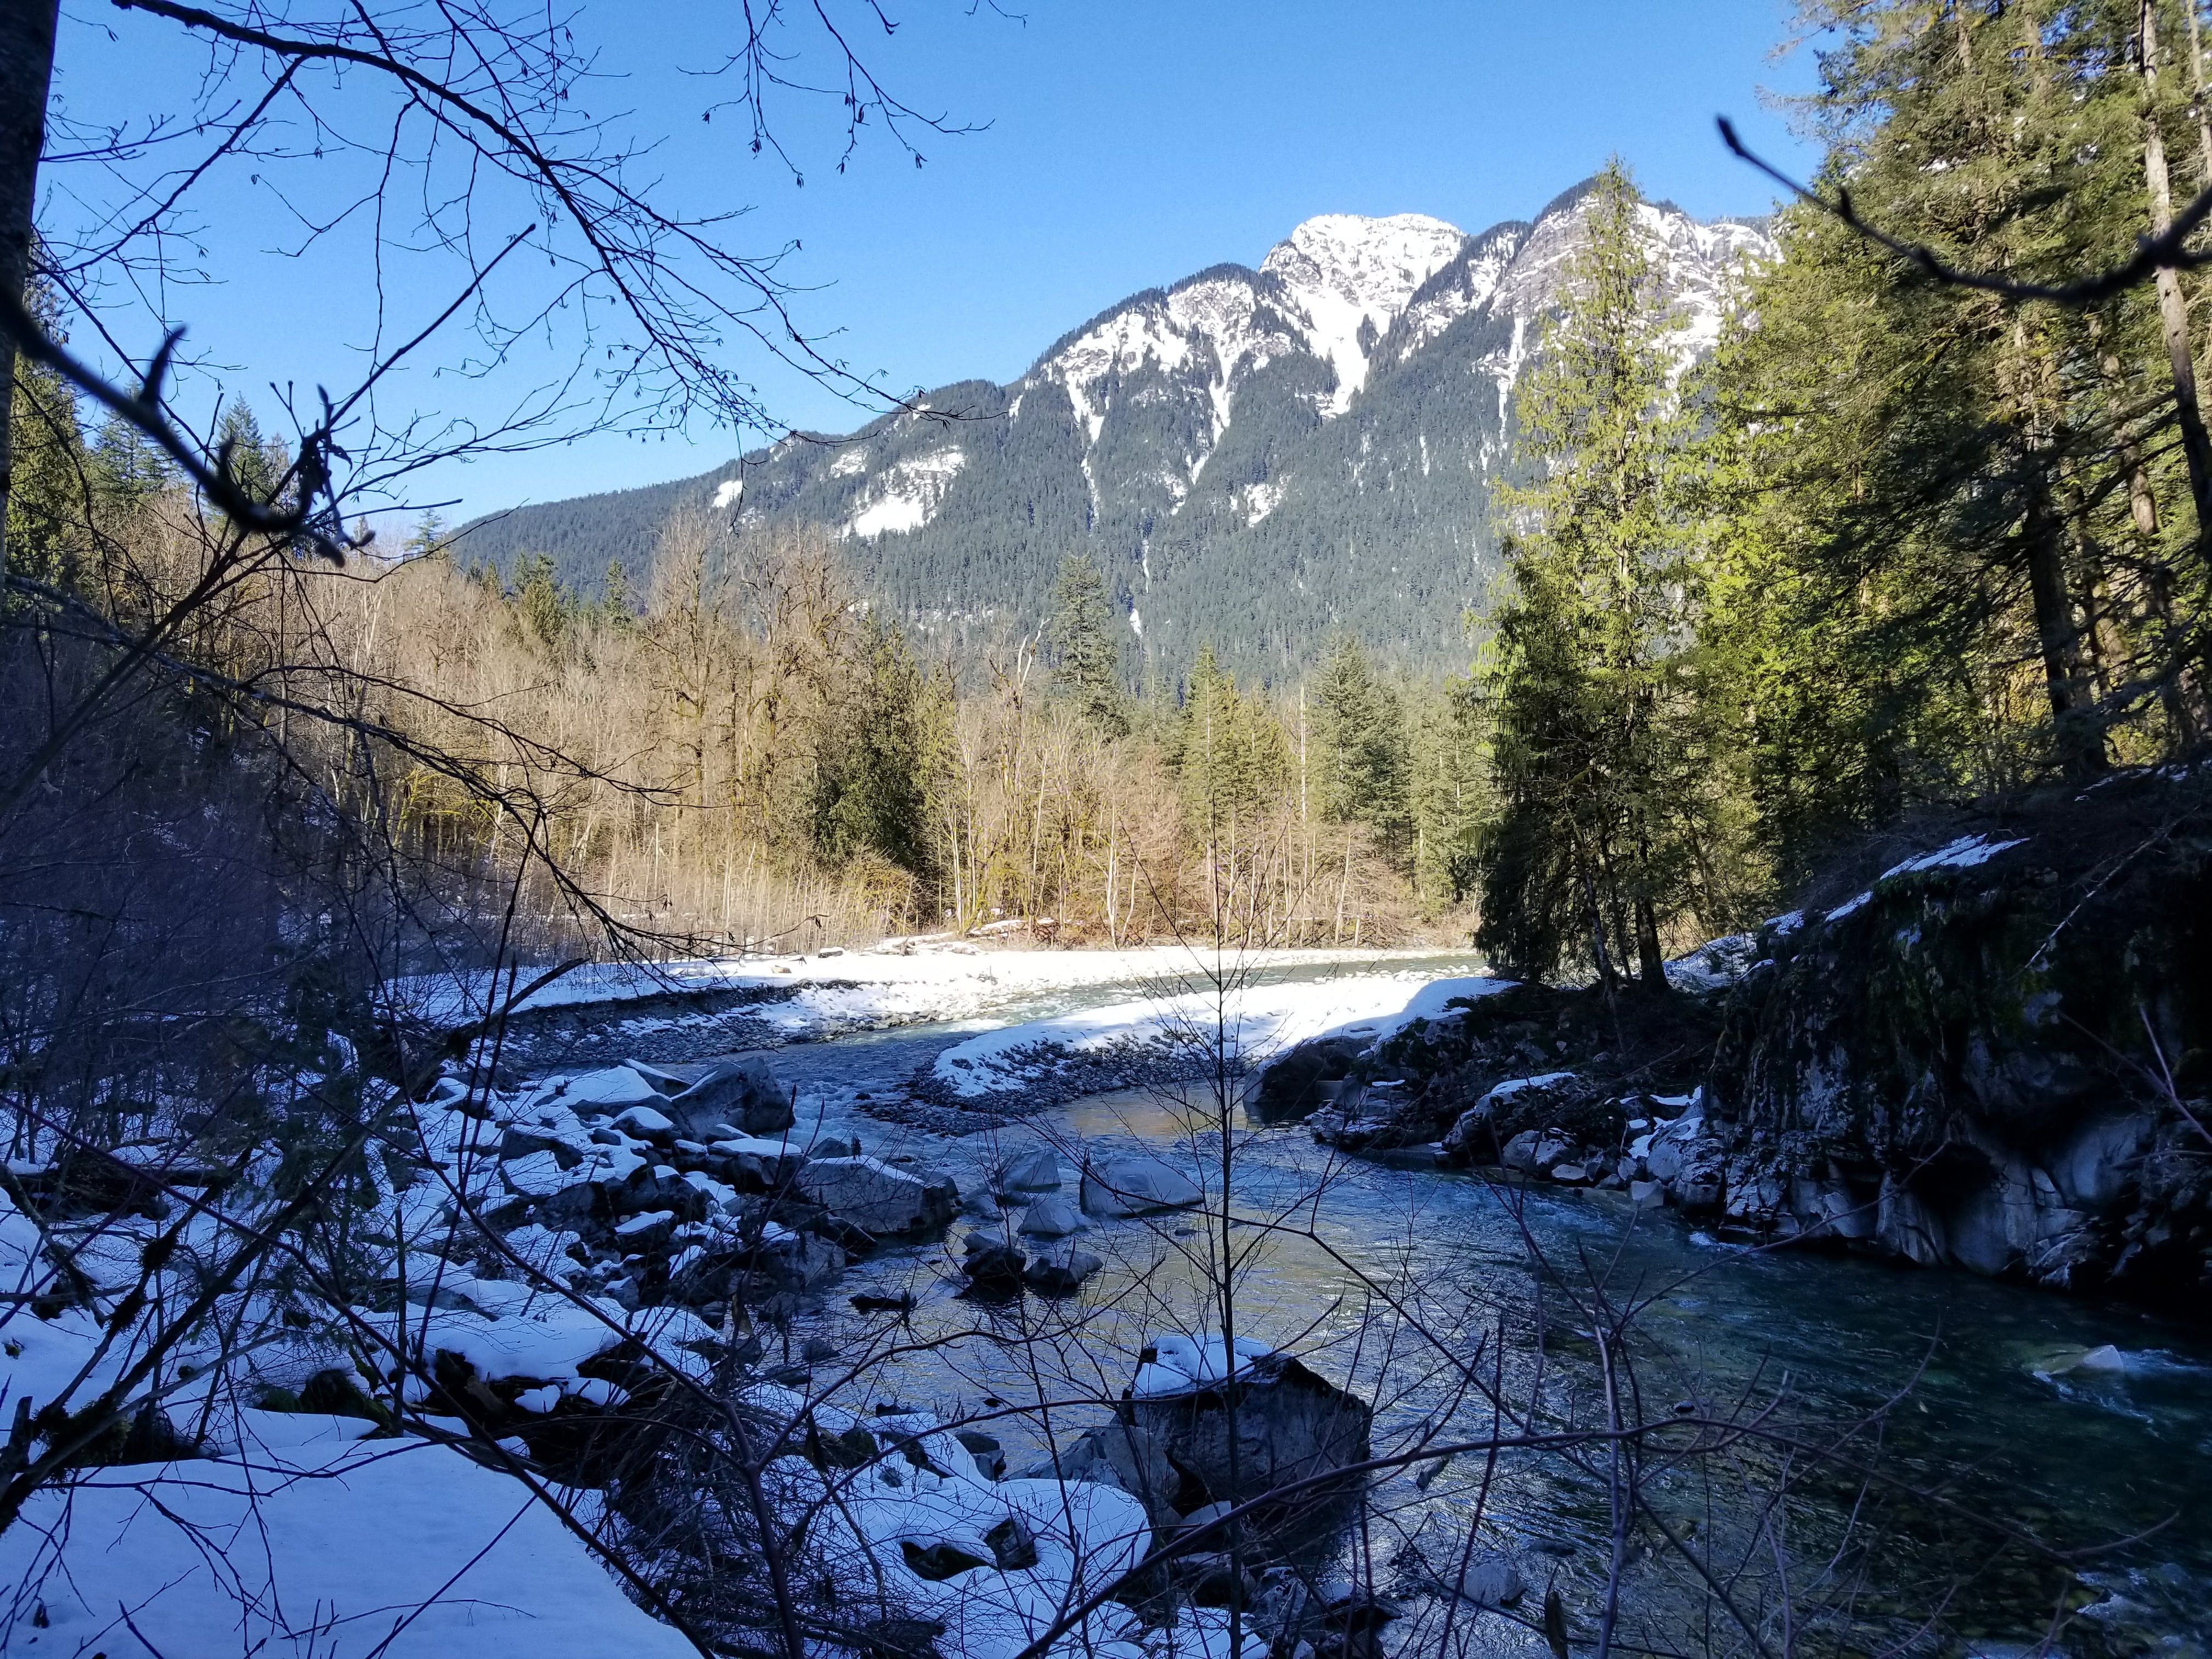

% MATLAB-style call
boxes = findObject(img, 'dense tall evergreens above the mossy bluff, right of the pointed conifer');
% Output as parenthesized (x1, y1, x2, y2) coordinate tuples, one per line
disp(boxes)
(1701, 0, 2212, 878)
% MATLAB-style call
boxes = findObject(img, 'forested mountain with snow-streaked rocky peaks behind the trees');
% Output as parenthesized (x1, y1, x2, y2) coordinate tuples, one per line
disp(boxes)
(462, 186, 1772, 675)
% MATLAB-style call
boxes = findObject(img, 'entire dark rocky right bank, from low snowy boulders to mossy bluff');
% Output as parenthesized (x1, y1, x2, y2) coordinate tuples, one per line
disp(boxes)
(1269, 765, 2212, 1314)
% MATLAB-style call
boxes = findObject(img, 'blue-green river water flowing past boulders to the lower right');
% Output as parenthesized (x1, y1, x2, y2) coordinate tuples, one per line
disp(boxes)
(624, 960, 2212, 1659)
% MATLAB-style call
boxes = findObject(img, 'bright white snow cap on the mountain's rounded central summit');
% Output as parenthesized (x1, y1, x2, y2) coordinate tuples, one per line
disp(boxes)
(1261, 212, 1466, 414)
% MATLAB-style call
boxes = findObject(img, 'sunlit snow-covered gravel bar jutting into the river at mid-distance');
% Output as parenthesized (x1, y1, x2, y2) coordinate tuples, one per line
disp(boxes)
(934, 969, 1506, 1099)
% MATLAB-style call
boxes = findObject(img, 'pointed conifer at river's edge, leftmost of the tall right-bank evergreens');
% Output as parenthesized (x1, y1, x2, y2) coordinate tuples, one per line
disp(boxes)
(1480, 161, 1697, 989)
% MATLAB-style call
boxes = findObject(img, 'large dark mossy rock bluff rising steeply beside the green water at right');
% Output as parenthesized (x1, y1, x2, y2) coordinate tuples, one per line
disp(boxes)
(1708, 774, 2212, 1310)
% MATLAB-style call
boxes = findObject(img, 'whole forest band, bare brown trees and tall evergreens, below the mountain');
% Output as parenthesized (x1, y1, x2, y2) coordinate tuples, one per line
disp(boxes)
(9, 4, 2212, 980)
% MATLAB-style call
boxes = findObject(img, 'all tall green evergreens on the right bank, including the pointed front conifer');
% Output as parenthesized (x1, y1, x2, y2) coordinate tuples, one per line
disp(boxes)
(1482, 0, 2212, 982)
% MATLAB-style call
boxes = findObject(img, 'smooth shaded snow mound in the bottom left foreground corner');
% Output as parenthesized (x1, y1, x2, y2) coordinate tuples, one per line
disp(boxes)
(0, 1411, 692, 1659)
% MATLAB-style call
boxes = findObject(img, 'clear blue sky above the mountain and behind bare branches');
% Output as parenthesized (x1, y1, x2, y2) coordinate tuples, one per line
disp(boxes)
(58, 0, 1814, 526)
